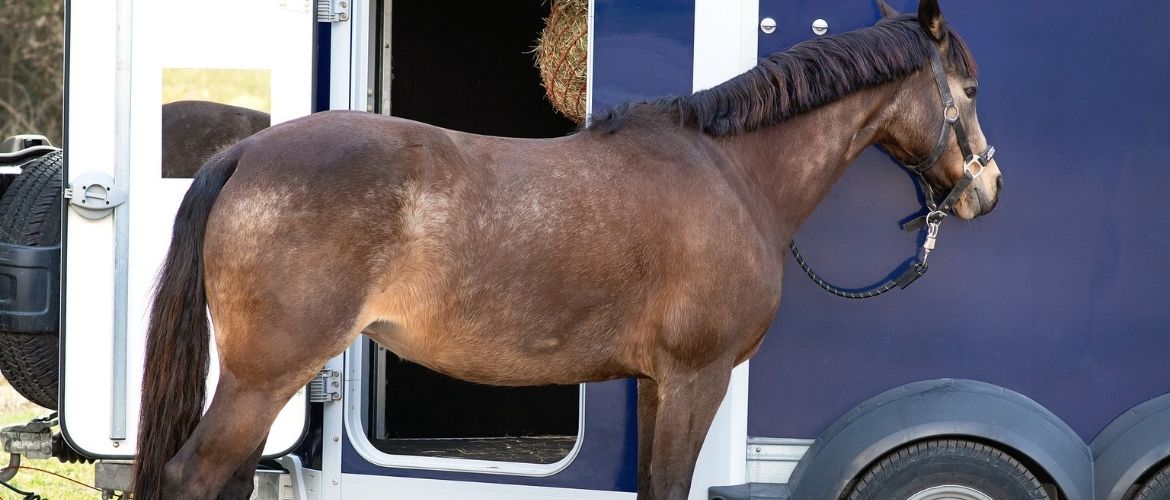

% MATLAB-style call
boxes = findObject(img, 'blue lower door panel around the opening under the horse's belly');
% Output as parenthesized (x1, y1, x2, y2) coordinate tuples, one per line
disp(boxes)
(342, 381, 638, 492)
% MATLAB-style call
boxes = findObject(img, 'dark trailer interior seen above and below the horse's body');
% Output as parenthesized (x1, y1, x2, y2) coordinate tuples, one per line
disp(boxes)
(366, 0, 580, 464)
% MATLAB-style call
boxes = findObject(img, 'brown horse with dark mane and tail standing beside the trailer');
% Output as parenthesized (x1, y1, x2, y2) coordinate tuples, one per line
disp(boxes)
(135, 0, 999, 500)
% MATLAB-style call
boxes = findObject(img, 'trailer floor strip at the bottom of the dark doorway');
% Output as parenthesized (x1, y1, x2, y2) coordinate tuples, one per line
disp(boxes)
(373, 436, 577, 464)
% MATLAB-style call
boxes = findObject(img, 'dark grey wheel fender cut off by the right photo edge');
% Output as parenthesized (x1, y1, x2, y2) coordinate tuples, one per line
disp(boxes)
(1092, 395, 1170, 500)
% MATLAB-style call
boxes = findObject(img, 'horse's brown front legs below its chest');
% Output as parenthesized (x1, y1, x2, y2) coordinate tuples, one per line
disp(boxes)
(638, 363, 731, 500)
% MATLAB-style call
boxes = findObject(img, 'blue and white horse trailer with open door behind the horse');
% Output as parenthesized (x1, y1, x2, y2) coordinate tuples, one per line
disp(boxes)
(0, 0, 1170, 500)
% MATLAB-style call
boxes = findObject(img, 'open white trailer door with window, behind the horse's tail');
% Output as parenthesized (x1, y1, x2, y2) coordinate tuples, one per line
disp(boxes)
(60, 0, 315, 458)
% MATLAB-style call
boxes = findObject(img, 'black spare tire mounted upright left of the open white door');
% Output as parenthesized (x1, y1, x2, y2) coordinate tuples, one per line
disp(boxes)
(0, 151, 62, 410)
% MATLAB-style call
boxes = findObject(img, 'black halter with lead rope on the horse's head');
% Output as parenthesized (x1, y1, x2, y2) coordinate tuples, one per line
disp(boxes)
(789, 44, 996, 299)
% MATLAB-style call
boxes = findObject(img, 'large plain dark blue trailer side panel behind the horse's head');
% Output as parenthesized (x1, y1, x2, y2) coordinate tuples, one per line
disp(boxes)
(748, 0, 1170, 441)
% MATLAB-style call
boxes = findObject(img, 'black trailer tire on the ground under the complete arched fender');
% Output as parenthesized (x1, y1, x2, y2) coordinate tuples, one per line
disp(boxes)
(845, 439, 1049, 500)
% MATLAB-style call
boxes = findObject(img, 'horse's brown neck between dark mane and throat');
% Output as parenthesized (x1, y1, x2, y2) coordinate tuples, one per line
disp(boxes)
(722, 83, 896, 244)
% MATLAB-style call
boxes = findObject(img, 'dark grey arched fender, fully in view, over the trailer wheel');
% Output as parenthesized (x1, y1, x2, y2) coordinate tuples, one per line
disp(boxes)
(789, 378, 1093, 500)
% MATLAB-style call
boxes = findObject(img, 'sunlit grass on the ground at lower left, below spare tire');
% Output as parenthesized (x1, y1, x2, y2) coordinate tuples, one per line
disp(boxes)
(0, 377, 102, 500)
